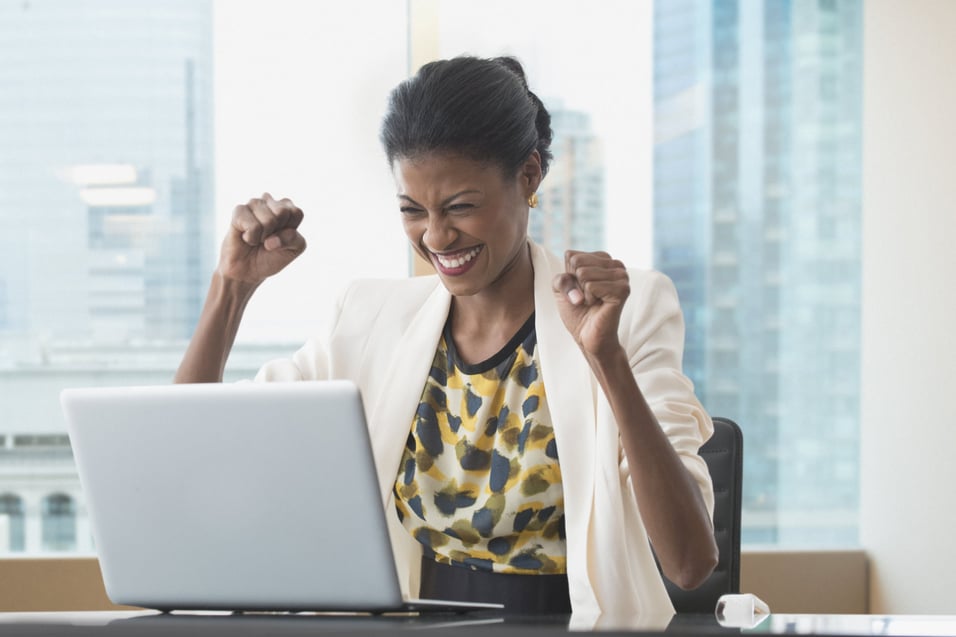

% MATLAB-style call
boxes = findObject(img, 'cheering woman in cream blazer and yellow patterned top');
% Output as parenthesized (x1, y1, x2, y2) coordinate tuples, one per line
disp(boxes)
(176, 57, 717, 614)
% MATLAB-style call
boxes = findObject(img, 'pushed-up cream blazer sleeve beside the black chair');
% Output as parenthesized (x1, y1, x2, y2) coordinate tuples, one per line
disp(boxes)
(620, 271, 714, 517)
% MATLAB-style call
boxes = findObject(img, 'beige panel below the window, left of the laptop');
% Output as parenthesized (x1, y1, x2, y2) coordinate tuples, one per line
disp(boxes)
(0, 557, 136, 611)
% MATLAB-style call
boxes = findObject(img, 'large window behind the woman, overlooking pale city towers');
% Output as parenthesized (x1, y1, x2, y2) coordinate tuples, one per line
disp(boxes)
(0, 0, 862, 553)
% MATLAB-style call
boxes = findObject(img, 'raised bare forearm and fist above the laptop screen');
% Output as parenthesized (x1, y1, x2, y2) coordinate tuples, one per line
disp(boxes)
(173, 193, 306, 383)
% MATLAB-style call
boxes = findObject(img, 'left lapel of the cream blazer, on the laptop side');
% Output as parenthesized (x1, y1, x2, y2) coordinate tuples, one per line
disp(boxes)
(369, 281, 451, 504)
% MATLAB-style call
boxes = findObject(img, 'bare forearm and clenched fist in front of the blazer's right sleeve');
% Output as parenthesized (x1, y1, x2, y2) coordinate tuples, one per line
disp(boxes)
(553, 251, 717, 589)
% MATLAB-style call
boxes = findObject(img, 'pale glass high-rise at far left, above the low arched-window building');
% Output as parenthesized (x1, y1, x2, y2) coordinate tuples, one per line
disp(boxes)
(0, 0, 214, 348)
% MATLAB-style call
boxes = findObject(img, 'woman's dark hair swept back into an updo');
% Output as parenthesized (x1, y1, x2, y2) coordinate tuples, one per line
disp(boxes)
(381, 56, 551, 174)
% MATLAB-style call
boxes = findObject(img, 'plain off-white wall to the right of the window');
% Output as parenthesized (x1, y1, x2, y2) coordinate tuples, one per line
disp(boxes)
(860, 0, 956, 613)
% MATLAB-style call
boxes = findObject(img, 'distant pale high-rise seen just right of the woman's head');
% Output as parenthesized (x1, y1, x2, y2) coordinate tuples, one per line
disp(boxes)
(528, 106, 605, 255)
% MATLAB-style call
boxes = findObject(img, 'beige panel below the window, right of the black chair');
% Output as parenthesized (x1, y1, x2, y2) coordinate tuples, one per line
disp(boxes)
(740, 550, 869, 614)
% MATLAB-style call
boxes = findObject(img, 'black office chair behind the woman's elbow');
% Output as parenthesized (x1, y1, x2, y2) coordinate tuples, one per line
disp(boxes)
(664, 417, 744, 613)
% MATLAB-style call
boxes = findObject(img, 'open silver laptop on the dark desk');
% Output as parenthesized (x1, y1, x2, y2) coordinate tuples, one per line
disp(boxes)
(60, 381, 502, 612)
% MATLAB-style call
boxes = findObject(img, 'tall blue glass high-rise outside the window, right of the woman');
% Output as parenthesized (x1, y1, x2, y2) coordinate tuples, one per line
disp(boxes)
(654, 0, 862, 545)
